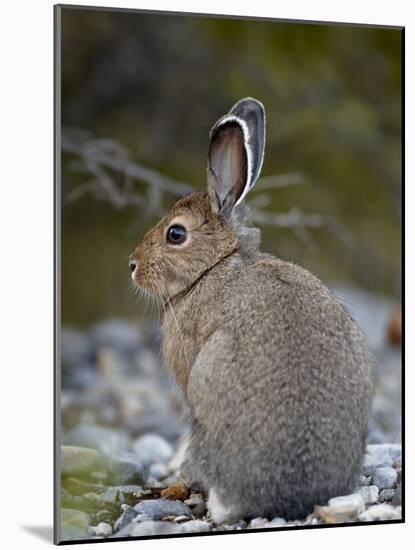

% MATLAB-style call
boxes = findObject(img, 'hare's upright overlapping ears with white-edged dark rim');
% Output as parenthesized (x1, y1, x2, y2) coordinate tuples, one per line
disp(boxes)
(208, 98, 265, 215)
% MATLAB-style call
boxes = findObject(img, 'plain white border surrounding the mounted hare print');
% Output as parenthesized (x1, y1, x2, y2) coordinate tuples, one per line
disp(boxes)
(0, 0, 415, 550)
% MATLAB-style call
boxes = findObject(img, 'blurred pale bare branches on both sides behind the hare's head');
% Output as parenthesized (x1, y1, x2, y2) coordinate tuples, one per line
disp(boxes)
(62, 128, 353, 247)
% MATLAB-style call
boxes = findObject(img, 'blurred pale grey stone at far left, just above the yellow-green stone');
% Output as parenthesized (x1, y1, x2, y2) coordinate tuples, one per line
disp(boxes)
(65, 424, 129, 455)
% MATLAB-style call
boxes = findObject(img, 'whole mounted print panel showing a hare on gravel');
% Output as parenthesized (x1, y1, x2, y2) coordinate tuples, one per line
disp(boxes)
(55, 5, 404, 544)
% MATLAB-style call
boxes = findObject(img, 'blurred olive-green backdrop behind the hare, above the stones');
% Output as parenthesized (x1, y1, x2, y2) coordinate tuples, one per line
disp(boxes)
(61, 8, 402, 325)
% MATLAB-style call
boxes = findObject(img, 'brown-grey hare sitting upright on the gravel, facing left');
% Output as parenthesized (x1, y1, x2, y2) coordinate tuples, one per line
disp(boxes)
(130, 98, 373, 523)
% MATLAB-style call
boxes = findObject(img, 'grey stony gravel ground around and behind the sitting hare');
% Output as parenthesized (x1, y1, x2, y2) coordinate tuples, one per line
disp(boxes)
(61, 287, 401, 540)
